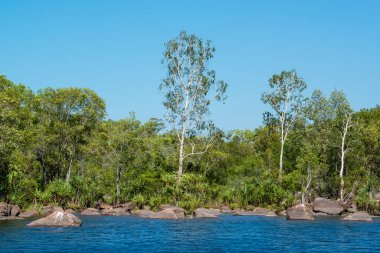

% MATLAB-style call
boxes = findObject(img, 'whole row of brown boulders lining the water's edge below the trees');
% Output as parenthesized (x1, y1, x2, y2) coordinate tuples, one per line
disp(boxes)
(0, 198, 378, 227)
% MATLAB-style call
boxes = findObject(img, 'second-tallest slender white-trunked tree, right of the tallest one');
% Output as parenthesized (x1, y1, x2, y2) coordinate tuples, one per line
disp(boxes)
(261, 70, 306, 182)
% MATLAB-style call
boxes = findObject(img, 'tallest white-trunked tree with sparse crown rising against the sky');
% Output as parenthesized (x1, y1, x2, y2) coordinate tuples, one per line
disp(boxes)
(160, 32, 227, 178)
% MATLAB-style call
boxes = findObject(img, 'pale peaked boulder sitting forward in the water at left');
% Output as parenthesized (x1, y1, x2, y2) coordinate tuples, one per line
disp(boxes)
(28, 211, 82, 227)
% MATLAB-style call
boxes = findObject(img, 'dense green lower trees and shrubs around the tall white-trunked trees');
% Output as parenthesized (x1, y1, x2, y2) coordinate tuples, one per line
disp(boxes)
(0, 73, 380, 212)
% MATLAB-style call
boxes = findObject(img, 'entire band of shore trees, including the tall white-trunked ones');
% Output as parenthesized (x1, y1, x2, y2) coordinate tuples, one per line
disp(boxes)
(0, 32, 380, 213)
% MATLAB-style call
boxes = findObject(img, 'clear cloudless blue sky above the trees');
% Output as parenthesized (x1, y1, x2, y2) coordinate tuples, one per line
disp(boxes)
(0, 0, 380, 130)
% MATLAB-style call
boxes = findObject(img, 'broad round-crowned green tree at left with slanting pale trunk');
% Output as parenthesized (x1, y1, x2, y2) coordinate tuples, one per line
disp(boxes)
(37, 88, 105, 183)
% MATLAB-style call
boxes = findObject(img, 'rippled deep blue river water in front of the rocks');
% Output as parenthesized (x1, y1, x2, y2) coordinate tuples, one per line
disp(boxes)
(0, 215, 380, 253)
